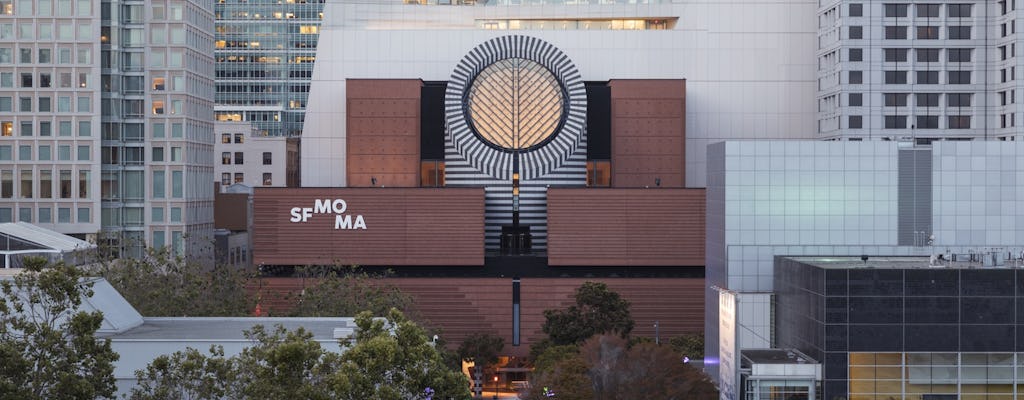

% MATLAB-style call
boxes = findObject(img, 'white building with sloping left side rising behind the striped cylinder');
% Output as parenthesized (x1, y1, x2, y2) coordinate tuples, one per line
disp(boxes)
(302, 0, 817, 187)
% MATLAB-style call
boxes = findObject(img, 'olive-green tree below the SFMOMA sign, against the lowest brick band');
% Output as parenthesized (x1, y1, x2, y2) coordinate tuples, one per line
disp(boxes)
(291, 266, 413, 317)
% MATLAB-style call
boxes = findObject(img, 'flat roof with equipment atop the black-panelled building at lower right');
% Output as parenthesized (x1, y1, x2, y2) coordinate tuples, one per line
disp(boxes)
(785, 255, 1024, 269)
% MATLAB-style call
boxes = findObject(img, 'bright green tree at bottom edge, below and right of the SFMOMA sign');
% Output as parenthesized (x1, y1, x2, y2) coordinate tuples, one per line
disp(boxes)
(332, 309, 469, 400)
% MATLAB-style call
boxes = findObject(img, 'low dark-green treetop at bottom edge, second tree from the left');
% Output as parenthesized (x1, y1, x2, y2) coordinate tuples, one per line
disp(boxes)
(129, 346, 232, 400)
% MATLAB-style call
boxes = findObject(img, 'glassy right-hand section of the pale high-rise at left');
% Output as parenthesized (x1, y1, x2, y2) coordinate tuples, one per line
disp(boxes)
(98, 0, 214, 255)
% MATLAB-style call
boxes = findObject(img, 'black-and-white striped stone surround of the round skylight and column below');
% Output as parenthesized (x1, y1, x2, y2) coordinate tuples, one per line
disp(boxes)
(444, 35, 587, 251)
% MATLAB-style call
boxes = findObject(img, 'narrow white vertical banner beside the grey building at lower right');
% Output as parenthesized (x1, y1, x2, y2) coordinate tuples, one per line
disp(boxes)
(718, 288, 739, 400)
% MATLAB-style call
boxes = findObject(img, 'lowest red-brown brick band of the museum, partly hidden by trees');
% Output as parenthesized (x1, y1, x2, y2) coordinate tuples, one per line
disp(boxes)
(256, 278, 705, 356)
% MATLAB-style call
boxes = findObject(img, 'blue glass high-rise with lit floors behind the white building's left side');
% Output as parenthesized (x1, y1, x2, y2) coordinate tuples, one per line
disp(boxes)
(208, 0, 324, 136)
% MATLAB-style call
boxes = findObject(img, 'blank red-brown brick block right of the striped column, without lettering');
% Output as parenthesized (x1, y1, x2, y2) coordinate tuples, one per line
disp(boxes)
(548, 188, 706, 266)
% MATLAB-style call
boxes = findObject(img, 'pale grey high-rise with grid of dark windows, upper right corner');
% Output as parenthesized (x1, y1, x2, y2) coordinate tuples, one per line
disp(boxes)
(817, 0, 1024, 143)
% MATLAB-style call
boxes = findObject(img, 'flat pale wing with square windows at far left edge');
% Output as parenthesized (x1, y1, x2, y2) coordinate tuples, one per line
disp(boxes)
(0, 0, 101, 238)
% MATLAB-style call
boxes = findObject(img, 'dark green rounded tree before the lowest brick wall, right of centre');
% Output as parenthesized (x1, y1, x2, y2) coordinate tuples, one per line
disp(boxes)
(543, 281, 633, 345)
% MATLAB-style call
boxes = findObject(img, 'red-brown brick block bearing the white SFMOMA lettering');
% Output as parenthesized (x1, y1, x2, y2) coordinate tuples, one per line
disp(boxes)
(253, 188, 483, 266)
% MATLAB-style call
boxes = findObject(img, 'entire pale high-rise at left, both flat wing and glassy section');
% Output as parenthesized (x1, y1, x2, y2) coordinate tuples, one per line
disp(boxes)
(0, 0, 213, 259)
